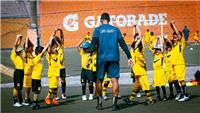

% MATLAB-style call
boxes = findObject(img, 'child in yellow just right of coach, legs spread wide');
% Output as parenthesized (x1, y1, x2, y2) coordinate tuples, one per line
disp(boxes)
(124, 26, 154, 104)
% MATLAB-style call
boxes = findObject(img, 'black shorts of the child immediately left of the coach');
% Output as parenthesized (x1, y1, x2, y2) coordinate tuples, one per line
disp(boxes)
(81, 68, 94, 82)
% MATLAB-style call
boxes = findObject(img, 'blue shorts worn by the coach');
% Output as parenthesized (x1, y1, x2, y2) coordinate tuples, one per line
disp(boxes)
(97, 60, 120, 79)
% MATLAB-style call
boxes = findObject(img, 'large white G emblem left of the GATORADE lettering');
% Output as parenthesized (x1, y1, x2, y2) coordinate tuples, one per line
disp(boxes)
(63, 14, 79, 31)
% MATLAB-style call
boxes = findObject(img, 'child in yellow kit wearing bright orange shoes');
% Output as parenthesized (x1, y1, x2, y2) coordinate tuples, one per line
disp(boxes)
(45, 36, 60, 105)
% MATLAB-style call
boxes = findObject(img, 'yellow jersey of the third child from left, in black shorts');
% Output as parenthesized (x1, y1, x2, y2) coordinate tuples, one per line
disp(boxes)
(31, 54, 43, 80)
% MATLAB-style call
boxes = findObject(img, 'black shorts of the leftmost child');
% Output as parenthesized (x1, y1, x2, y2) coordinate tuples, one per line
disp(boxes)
(13, 69, 24, 90)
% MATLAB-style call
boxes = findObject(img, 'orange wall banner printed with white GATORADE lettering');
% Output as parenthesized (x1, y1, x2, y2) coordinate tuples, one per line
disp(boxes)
(40, 1, 200, 47)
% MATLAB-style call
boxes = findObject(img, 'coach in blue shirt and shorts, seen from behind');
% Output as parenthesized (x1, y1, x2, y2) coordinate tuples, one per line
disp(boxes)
(90, 13, 132, 111)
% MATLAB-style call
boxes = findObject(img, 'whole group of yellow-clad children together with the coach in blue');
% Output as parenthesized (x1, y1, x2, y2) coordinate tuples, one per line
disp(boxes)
(10, 13, 189, 111)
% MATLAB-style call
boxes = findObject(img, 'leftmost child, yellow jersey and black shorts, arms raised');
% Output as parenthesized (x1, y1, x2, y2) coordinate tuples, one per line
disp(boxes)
(10, 35, 24, 107)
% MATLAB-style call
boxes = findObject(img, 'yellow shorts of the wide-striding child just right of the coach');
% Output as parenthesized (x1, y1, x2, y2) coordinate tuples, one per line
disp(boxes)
(135, 75, 150, 91)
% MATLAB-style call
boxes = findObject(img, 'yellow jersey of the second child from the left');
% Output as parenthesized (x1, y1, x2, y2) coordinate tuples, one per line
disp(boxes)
(22, 52, 34, 75)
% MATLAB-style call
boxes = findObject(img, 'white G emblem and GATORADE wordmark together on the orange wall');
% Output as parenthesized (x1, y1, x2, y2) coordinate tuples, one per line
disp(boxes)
(63, 13, 167, 31)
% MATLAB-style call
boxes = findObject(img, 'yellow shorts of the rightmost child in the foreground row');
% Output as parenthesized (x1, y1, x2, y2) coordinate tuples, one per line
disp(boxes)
(174, 64, 186, 81)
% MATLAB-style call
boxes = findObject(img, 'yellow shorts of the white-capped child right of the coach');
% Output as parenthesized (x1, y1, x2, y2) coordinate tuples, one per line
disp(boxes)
(153, 69, 167, 87)
